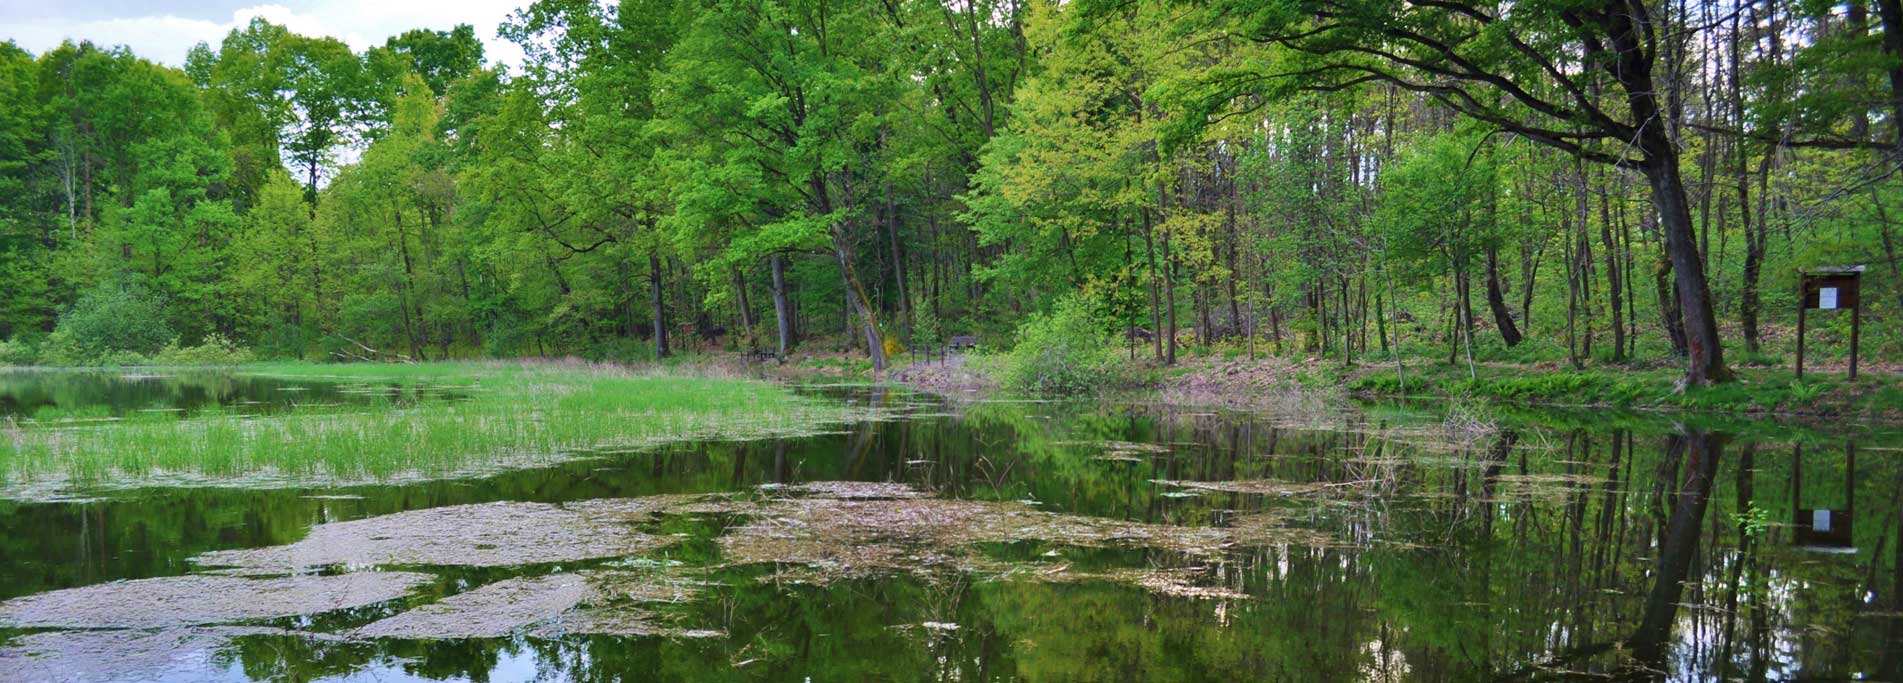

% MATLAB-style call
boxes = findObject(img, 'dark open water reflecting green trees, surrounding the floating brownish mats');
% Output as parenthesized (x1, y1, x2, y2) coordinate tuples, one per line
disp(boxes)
(0, 394, 1903, 681)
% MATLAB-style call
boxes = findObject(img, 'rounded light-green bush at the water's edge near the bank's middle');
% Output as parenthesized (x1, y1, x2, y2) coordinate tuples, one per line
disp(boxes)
(1005, 297, 1117, 394)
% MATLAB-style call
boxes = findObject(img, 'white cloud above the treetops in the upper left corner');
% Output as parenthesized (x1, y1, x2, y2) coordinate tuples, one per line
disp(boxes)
(0, 0, 529, 67)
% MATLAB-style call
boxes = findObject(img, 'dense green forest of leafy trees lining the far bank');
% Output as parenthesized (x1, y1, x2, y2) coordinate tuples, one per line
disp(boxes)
(0, 0, 1903, 393)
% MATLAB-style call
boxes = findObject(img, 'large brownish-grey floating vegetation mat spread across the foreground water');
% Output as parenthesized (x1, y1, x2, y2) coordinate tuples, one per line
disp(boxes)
(0, 481, 1332, 654)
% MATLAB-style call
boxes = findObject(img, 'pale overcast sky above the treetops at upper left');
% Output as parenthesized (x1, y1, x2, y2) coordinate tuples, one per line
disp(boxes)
(0, 0, 531, 67)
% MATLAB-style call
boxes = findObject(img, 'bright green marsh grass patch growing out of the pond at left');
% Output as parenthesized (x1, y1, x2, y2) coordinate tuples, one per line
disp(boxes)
(0, 363, 863, 497)
